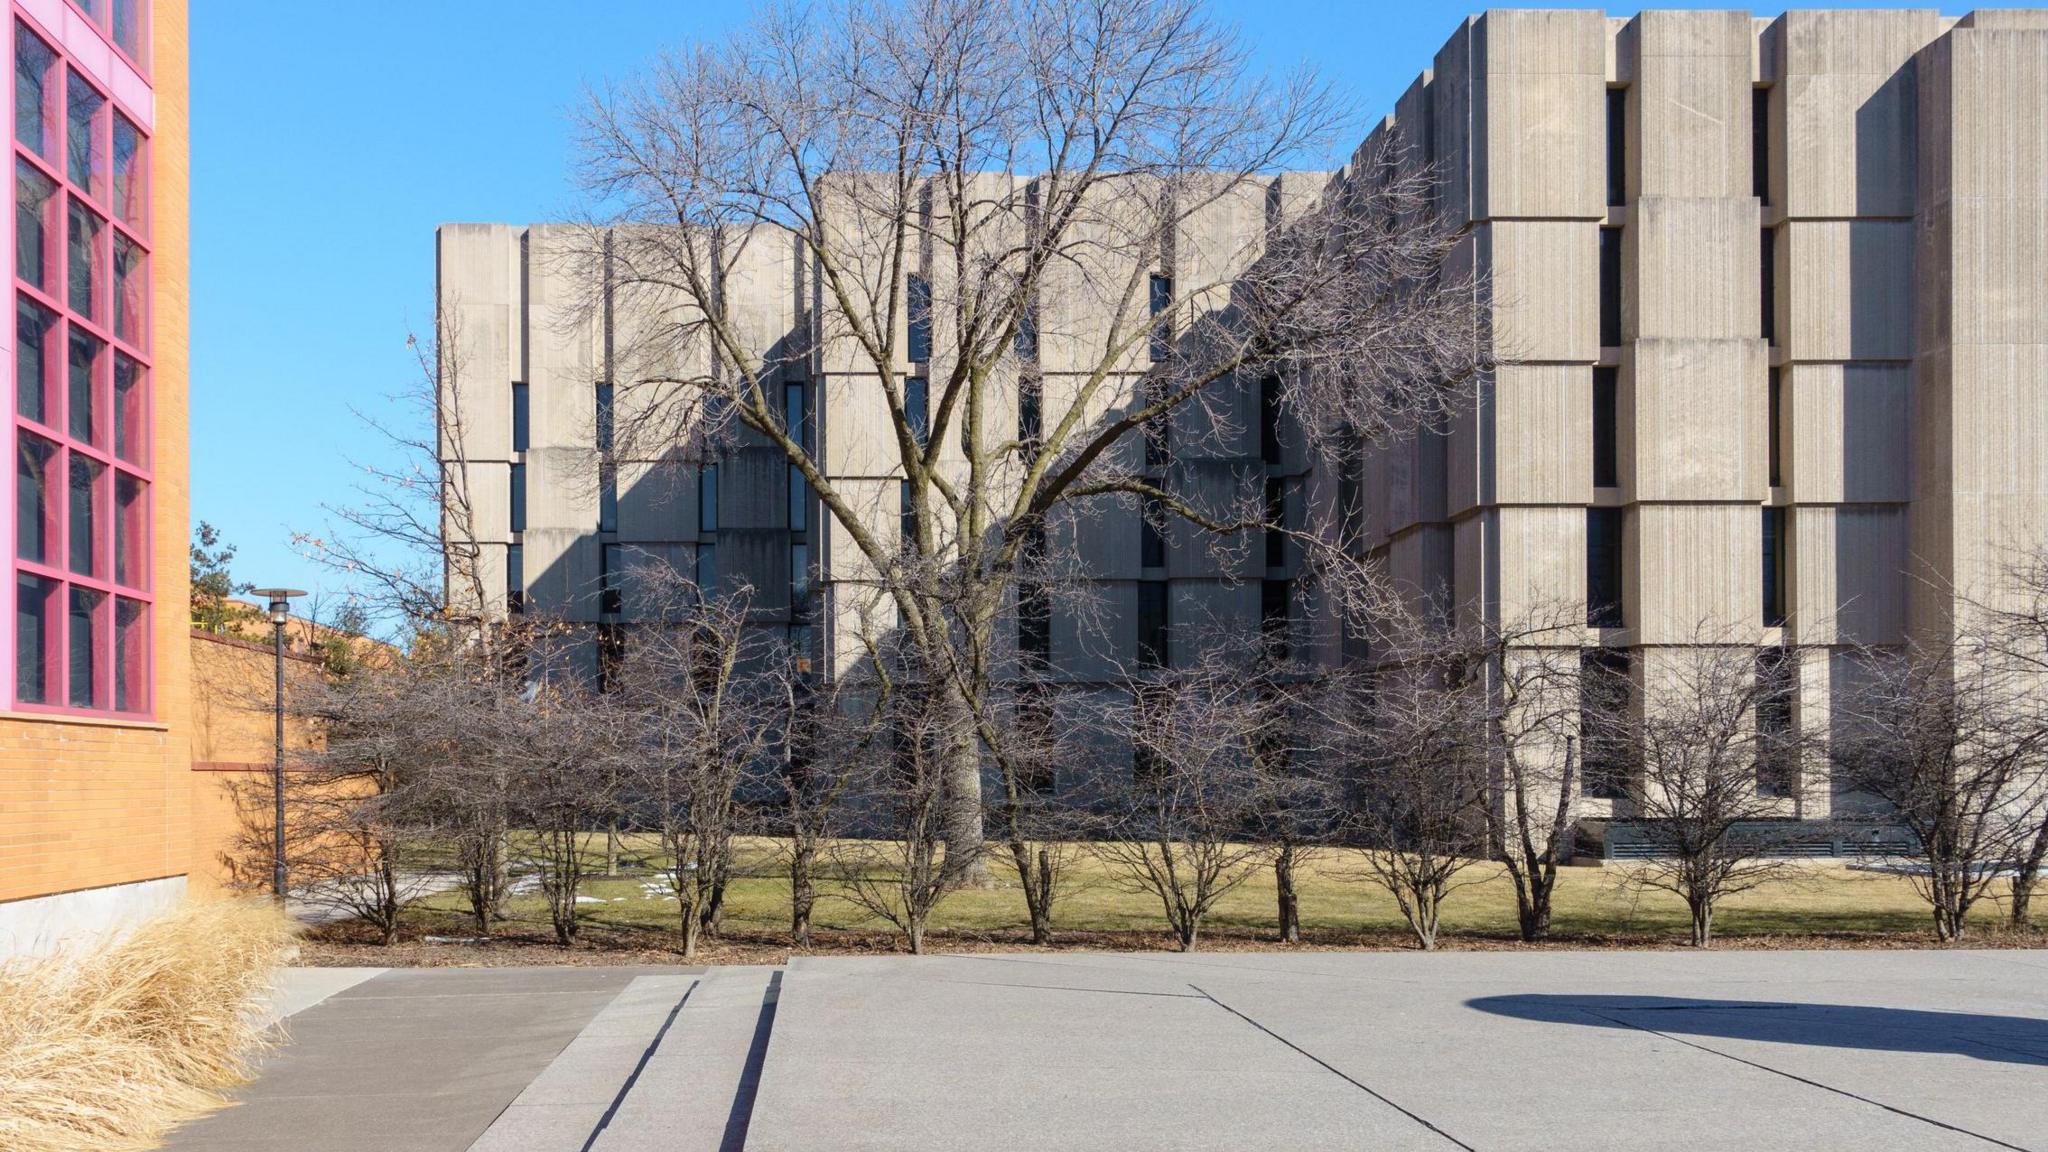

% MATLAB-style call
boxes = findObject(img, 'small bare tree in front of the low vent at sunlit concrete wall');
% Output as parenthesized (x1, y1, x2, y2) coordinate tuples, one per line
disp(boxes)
(1581, 627, 1806, 947)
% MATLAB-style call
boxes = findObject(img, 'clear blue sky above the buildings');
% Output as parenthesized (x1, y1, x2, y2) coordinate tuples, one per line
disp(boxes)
(193, 0, 1966, 605)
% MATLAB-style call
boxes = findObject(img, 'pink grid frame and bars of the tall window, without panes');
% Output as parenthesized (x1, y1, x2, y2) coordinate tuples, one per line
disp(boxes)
(0, 0, 156, 719)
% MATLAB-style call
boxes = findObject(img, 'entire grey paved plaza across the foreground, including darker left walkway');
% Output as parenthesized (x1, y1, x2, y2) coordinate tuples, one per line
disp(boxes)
(172, 951, 2048, 1152)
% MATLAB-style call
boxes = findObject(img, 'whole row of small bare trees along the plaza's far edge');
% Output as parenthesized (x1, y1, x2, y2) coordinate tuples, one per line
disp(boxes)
(268, 557, 2048, 955)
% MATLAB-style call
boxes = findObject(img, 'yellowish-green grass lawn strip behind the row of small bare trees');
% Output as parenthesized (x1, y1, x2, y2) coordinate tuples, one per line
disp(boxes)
(356, 836, 2048, 951)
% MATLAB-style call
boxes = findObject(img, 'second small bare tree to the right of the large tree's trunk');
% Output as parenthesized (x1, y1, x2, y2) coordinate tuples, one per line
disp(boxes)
(1092, 652, 1270, 951)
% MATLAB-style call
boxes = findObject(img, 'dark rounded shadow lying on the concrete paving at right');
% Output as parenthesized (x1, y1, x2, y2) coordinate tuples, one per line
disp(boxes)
(1464, 994, 2048, 1066)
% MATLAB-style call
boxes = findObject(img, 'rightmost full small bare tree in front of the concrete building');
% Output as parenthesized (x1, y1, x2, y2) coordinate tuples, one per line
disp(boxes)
(1831, 629, 2048, 941)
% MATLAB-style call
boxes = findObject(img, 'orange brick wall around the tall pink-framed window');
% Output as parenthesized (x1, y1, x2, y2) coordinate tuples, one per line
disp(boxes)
(0, 0, 195, 902)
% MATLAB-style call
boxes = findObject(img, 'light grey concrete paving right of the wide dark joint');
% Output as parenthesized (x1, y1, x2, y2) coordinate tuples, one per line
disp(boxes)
(750, 951, 2048, 1152)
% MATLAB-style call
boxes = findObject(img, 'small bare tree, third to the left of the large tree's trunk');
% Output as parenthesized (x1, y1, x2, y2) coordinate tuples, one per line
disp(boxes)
(621, 566, 791, 957)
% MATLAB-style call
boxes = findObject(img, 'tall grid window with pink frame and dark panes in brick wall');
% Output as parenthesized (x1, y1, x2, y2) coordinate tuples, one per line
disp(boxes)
(12, 22, 154, 715)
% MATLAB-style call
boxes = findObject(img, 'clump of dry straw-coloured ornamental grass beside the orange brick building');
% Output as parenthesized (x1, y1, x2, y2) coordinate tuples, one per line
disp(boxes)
(0, 900, 291, 1152)
